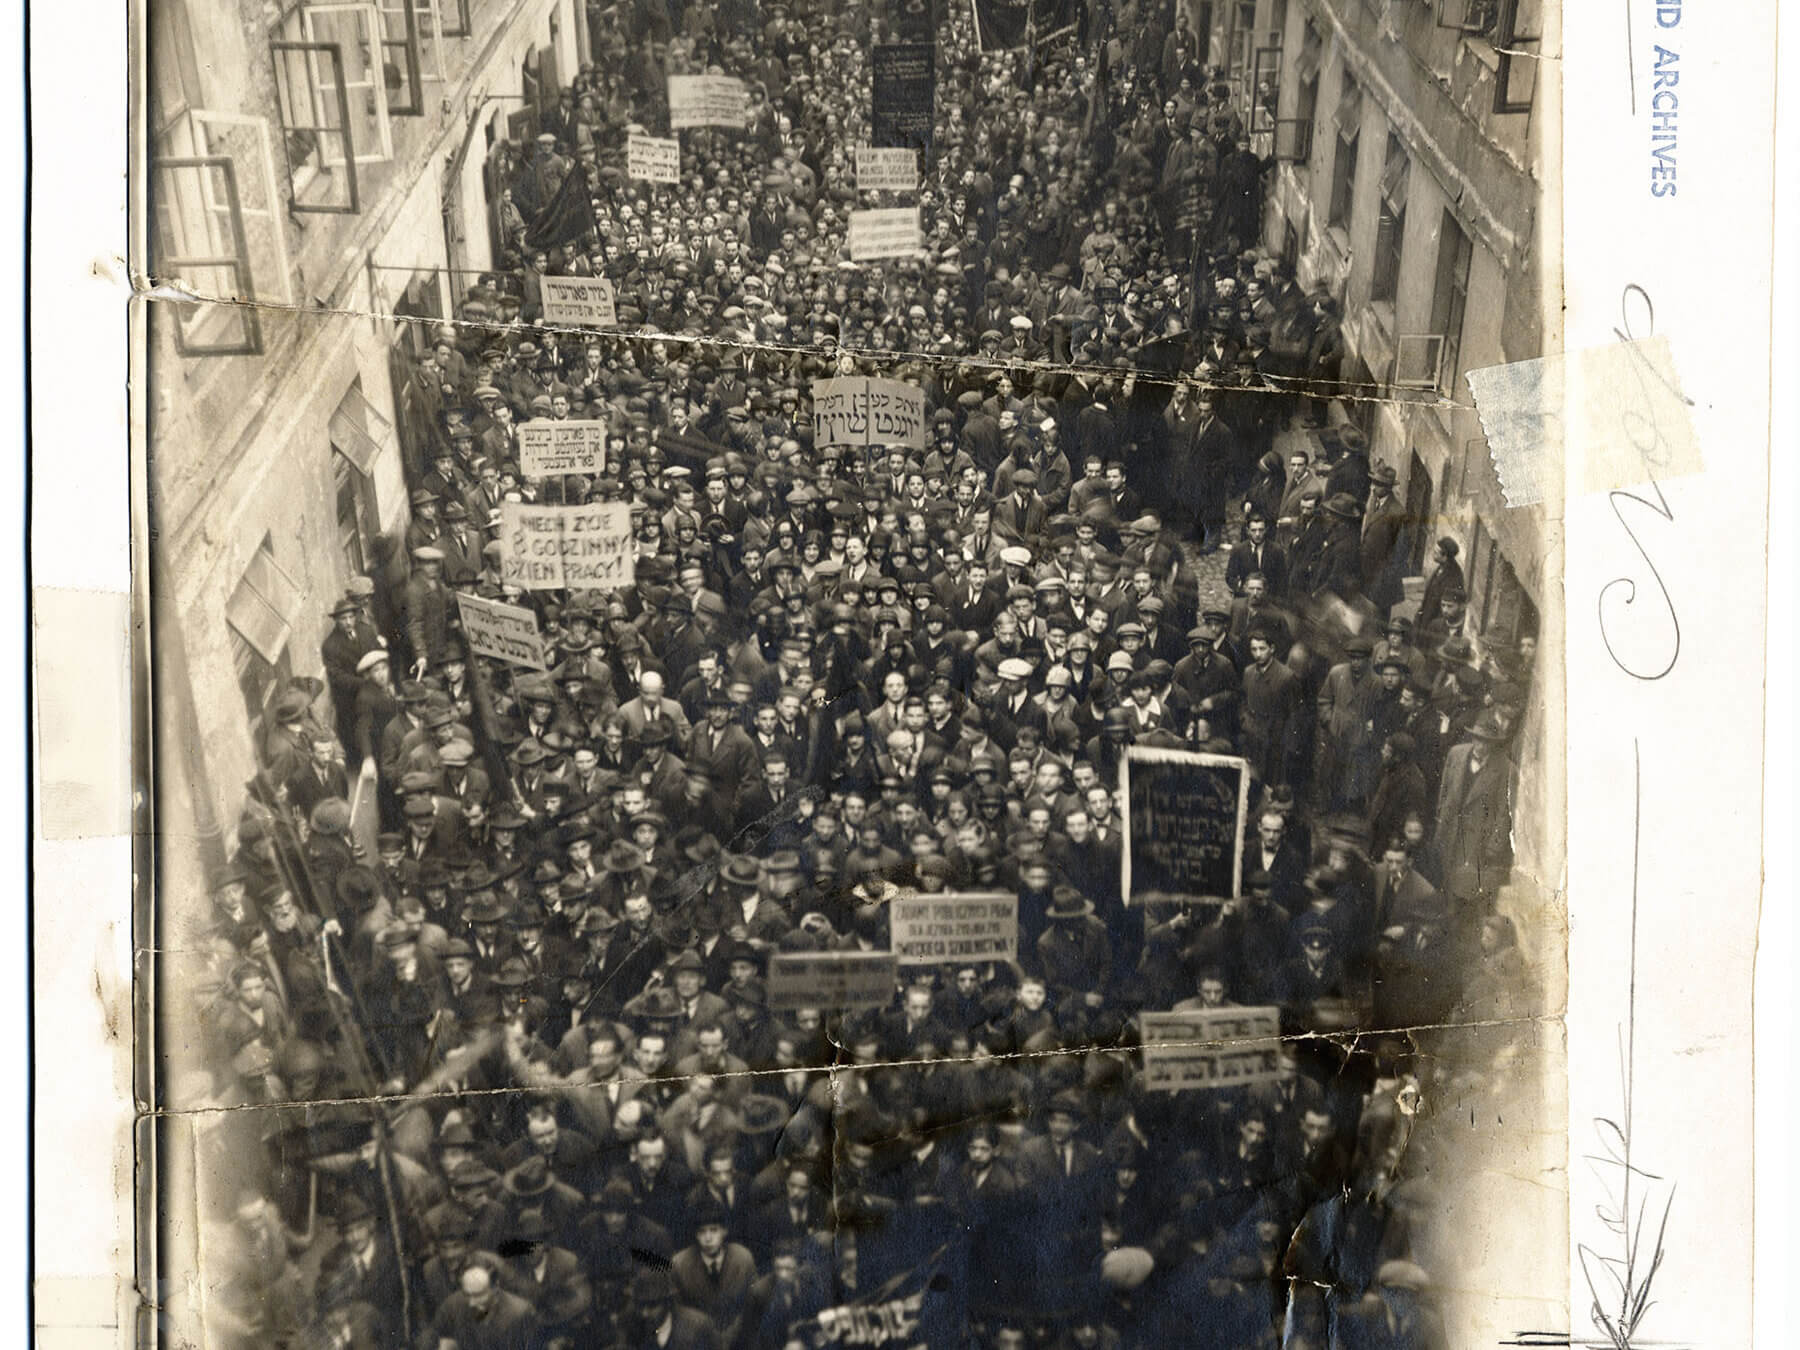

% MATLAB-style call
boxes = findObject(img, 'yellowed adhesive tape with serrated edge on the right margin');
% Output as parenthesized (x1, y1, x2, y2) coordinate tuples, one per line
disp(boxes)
(1467, 337, 1705, 506)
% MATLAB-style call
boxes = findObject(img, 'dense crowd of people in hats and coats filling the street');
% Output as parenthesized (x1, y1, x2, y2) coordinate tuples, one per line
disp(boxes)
(176, 0, 1534, 1350)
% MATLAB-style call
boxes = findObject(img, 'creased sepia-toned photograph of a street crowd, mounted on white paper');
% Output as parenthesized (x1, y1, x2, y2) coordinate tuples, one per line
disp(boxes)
(133, 0, 1562, 1350)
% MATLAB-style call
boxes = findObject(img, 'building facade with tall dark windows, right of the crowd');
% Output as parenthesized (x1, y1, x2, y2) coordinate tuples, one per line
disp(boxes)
(1245, 0, 1562, 903)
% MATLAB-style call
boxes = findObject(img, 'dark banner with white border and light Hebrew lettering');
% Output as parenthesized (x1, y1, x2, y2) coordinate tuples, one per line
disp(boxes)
(1120, 745, 1249, 902)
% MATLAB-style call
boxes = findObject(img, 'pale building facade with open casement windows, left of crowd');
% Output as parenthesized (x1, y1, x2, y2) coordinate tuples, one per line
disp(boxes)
(140, 0, 589, 921)
